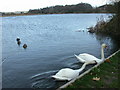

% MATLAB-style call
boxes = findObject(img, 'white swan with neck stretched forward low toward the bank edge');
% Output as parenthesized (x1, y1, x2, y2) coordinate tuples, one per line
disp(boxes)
(51, 63, 87, 81)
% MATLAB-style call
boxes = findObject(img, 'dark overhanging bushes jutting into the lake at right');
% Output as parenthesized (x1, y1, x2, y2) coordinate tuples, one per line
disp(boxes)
(88, 1, 120, 40)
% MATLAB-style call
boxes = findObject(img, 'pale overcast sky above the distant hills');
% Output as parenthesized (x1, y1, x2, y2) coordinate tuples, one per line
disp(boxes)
(0, 0, 107, 12)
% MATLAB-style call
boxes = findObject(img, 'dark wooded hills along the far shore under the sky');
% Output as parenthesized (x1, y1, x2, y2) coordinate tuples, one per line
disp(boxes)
(2, 3, 115, 16)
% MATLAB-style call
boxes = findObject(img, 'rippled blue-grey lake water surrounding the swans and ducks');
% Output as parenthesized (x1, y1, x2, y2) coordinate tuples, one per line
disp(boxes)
(2, 14, 118, 88)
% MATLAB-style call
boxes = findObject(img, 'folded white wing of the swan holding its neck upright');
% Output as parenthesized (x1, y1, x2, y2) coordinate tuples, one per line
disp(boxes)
(78, 53, 98, 62)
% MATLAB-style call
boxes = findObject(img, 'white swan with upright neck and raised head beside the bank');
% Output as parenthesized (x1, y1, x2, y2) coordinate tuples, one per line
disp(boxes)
(75, 44, 107, 64)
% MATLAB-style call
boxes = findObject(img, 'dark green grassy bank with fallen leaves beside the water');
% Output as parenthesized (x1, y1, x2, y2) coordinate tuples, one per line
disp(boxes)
(64, 52, 120, 89)
